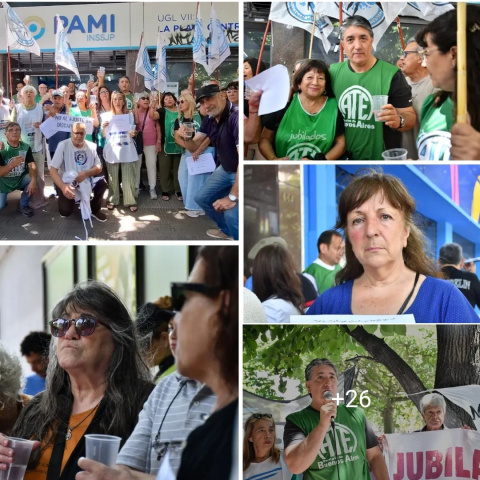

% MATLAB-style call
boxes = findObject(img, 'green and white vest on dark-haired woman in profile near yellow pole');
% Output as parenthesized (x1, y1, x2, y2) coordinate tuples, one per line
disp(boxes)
(417, 95, 454, 160)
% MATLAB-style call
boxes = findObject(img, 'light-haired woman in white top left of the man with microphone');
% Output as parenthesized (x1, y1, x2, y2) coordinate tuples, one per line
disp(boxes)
(243, 413, 292, 480)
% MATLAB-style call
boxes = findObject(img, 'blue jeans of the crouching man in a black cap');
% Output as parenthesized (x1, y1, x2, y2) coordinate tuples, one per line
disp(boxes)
(195, 166, 238, 240)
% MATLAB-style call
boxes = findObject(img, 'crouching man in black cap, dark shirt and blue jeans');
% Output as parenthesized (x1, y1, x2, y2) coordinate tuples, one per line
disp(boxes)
(179, 84, 238, 240)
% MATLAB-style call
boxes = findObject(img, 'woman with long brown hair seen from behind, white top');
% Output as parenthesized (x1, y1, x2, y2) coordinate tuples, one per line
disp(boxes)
(252, 243, 308, 323)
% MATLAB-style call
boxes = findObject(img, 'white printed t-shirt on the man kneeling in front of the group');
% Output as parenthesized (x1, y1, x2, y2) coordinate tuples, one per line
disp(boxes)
(51, 138, 101, 177)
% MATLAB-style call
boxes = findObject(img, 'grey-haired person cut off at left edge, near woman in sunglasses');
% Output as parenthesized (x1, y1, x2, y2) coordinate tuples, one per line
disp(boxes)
(0, 343, 30, 434)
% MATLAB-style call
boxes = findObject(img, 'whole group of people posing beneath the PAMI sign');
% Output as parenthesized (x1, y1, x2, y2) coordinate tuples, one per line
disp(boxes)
(0, 69, 238, 240)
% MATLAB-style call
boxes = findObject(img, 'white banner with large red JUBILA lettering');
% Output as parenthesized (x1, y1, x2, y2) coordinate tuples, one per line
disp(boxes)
(383, 428, 480, 480)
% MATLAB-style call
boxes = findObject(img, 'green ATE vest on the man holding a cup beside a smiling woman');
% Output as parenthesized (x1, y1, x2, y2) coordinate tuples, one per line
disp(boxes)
(330, 60, 398, 160)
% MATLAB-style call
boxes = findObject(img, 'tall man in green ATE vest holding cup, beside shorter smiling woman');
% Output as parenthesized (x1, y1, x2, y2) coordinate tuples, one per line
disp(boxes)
(330, 15, 416, 160)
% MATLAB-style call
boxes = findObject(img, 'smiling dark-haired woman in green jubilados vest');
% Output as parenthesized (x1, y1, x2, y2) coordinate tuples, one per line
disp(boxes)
(259, 60, 345, 160)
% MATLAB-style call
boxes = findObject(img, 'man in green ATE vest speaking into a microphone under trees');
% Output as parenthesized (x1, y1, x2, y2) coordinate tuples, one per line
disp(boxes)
(283, 358, 388, 480)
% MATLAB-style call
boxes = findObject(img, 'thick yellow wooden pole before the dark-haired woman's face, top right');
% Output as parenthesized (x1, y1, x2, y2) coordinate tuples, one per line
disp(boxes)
(456, 2, 467, 123)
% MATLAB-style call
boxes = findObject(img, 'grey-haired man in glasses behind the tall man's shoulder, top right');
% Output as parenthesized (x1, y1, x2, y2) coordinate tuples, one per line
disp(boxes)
(401, 38, 438, 159)
